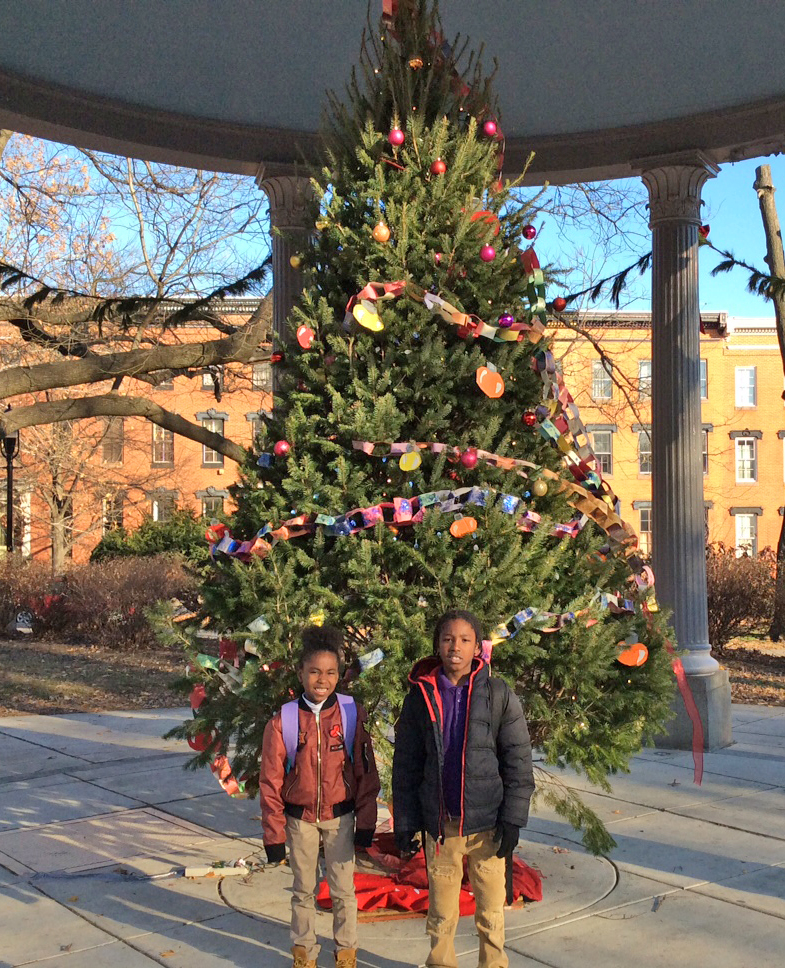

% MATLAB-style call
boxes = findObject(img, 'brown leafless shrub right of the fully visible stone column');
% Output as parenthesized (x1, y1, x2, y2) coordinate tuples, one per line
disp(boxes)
(706, 543, 775, 655)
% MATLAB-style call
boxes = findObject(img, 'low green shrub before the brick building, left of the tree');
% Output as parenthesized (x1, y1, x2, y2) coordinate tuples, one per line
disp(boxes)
(90, 509, 210, 567)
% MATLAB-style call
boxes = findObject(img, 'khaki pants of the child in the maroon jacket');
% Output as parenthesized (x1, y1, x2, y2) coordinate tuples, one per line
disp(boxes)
(286, 813, 357, 961)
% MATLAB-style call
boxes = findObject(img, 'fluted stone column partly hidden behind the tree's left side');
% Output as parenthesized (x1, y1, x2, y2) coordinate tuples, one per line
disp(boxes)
(256, 169, 313, 393)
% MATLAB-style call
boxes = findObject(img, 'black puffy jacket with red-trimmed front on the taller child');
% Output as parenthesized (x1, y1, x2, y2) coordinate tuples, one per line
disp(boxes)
(393, 658, 534, 839)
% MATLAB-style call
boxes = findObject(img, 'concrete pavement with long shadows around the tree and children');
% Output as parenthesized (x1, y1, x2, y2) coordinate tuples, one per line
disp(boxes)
(0, 706, 785, 968)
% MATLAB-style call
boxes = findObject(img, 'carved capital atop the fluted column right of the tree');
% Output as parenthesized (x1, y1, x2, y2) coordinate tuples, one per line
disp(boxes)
(634, 151, 720, 228)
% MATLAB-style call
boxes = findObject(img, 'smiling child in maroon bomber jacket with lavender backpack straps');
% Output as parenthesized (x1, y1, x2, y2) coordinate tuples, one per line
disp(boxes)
(259, 625, 379, 968)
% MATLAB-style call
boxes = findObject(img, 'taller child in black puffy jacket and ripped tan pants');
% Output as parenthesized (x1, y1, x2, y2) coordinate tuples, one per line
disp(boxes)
(393, 609, 534, 968)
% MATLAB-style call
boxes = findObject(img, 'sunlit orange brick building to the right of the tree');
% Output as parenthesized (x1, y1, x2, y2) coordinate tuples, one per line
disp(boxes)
(554, 312, 785, 553)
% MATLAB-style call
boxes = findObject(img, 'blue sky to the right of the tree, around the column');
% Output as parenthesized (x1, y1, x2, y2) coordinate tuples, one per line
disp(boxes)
(535, 156, 785, 317)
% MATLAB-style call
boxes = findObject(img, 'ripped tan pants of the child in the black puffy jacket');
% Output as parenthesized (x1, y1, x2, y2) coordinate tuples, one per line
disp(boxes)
(425, 820, 508, 968)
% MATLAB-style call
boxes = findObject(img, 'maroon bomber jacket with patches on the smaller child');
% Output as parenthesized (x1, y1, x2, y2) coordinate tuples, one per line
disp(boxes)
(259, 693, 379, 847)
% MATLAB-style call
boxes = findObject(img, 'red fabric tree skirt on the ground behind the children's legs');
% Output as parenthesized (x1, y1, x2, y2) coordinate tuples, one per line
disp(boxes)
(316, 833, 542, 917)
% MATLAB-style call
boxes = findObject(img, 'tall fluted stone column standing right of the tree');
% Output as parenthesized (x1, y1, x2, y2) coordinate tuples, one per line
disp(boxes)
(636, 152, 732, 749)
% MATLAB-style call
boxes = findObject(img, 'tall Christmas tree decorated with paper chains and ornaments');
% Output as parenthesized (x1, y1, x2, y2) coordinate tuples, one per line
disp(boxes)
(170, 0, 672, 850)
